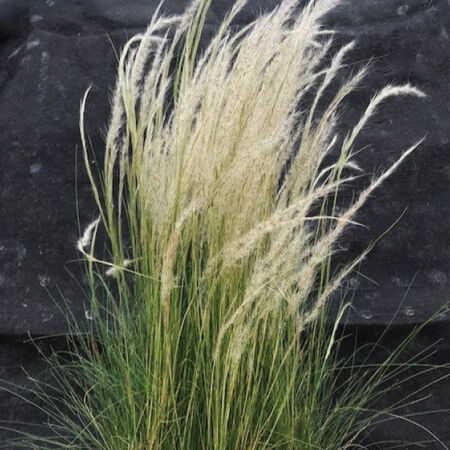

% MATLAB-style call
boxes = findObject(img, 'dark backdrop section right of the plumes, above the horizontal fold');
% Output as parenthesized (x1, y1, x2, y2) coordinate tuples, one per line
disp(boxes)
(330, 1, 450, 323)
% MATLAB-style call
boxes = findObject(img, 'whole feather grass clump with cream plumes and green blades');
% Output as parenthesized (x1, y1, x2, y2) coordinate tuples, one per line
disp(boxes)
(7, 0, 446, 450)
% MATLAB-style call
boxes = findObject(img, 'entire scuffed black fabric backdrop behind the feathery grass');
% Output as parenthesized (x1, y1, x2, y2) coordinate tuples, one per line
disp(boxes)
(0, 0, 450, 448)
